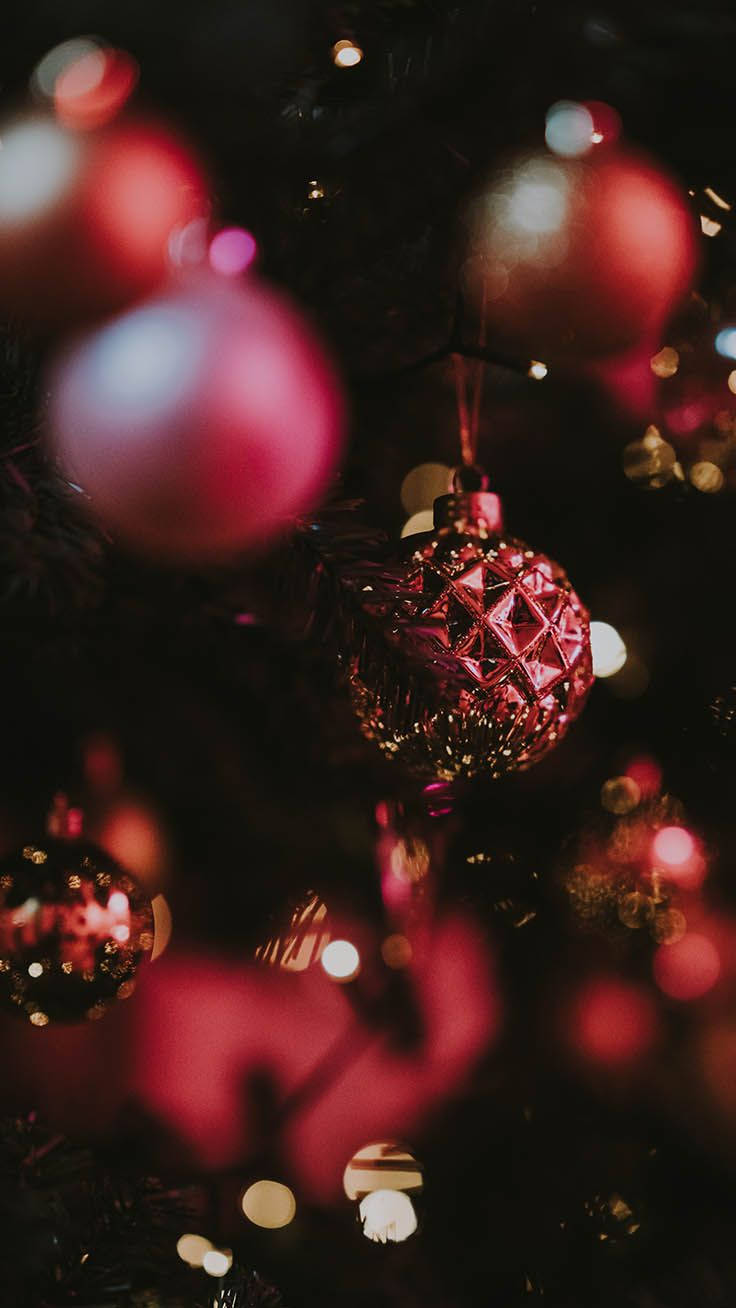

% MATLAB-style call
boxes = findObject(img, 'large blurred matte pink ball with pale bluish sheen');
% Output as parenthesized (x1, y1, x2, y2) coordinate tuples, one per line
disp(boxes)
(50, 275, 344, 560)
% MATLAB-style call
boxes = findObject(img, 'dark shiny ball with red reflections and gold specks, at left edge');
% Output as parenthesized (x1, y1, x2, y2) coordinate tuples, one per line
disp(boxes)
(0, 836, 153, 1027)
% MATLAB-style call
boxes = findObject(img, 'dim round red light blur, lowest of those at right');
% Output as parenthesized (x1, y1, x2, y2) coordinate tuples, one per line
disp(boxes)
(571, 978, 656, 1065)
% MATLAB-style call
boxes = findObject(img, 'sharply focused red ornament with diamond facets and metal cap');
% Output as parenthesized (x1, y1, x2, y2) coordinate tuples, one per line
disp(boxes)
(348, 468, 592, 780)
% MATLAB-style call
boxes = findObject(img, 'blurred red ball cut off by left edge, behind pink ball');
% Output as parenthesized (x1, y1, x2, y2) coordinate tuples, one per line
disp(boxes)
(0, 115, 208, 327)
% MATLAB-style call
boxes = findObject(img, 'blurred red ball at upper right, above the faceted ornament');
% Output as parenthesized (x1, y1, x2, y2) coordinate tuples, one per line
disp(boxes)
(464, 149, 697, 360)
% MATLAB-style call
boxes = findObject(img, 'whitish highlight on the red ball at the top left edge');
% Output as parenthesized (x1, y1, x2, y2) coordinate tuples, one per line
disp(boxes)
(0, 118, 80, 224)
